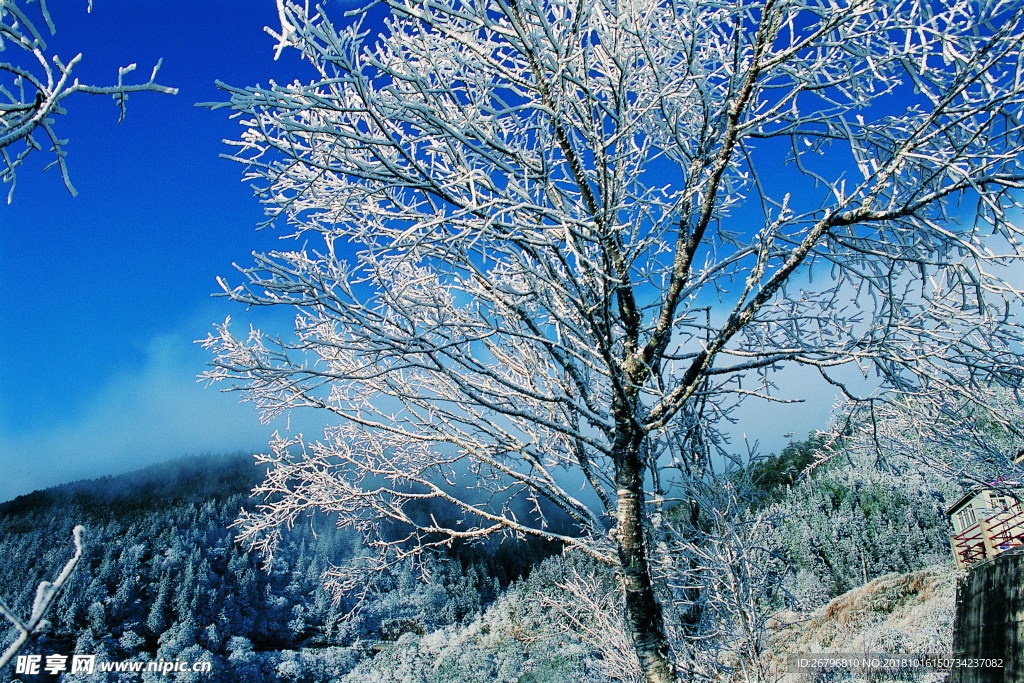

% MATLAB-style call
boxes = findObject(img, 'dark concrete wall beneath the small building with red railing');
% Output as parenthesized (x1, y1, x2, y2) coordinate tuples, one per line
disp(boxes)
(949, 551, 1024, 683)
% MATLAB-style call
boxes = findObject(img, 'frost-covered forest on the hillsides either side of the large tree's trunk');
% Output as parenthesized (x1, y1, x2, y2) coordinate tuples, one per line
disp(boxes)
(0, 430, 955, 682)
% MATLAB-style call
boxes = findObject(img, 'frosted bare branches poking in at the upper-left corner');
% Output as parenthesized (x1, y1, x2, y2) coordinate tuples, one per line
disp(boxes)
(0, 0, 177, 203)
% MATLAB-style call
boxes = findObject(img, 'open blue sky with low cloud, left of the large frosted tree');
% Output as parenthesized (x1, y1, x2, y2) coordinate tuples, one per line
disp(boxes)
(0, 0, 831, 501)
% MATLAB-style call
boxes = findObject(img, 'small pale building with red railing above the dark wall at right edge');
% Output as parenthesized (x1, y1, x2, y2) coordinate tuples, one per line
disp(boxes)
(946, 481, 1024, 569)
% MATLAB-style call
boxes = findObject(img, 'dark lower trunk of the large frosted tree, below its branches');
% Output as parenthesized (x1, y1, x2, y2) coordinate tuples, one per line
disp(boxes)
(616, 449, 677, 683)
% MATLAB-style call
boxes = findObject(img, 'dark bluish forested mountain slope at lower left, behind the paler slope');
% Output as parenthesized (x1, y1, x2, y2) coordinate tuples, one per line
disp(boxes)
(0, 450, 573, 682)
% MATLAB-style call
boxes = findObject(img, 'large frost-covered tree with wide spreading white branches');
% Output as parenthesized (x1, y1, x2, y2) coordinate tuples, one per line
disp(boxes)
(206, 0, 1024, 681)
